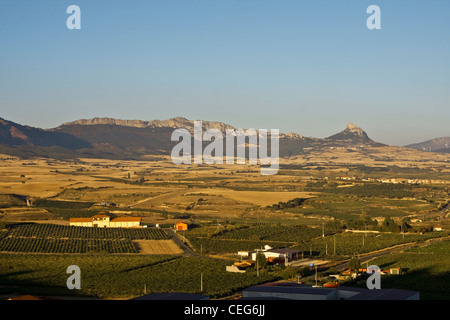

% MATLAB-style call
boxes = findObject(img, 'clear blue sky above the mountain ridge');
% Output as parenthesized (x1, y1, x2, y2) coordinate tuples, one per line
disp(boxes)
(0, 0, 450, 145)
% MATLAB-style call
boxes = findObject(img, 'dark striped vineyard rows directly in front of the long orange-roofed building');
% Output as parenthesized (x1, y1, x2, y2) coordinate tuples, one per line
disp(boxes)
(0, 224, 169, 253)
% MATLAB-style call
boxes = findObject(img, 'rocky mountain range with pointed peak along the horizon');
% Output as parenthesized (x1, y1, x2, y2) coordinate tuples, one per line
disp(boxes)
(0, 117, 444, 160)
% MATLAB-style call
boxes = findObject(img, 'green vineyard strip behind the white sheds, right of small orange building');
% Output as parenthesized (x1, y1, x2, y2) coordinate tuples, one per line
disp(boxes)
(185, 224, 448, 259)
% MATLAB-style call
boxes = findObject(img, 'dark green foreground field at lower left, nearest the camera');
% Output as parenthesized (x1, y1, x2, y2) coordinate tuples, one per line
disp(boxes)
(0, 254, 282, 299)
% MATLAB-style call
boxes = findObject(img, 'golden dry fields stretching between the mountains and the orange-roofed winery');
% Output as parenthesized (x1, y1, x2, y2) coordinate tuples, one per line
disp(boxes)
(0, 146, 450, 228)
